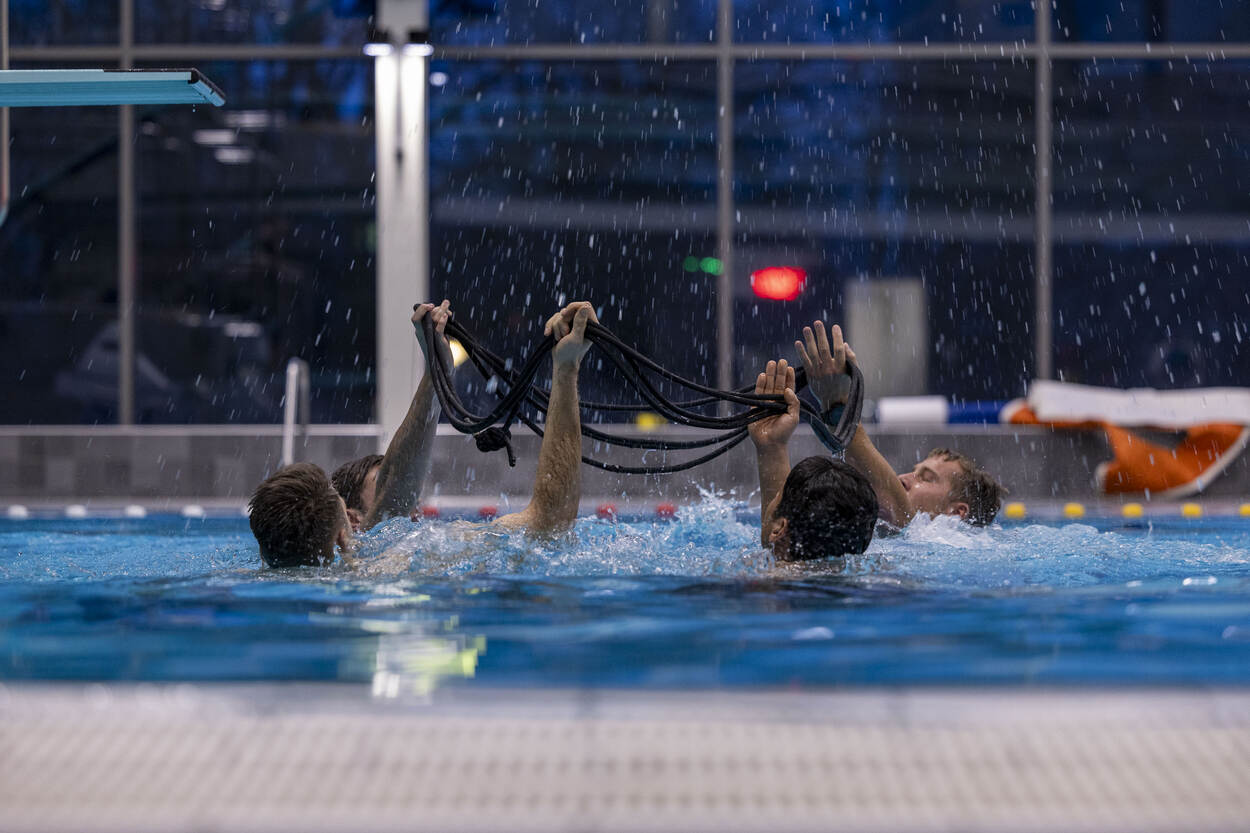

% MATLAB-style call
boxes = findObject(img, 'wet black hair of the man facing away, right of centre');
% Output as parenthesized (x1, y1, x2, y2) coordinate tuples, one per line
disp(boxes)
(773, 457, 878, 560)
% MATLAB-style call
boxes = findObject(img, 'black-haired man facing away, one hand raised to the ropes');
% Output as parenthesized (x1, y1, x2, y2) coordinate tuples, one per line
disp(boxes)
(750, 359, 878, 562)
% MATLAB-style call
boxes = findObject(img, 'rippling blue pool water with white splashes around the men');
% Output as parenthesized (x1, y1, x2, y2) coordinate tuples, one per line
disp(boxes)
(0, 498, 1250, 695)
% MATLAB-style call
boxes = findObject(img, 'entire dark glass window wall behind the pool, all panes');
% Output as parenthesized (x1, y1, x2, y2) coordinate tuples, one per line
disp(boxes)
(0, 0, 1250, 423)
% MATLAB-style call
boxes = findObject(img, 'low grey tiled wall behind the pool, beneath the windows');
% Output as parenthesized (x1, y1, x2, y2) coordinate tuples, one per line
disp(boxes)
(0, 425, 1250, 502)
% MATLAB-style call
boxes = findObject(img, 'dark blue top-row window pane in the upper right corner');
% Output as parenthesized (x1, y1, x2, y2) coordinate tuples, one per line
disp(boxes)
(1054, 0, 1250, 43)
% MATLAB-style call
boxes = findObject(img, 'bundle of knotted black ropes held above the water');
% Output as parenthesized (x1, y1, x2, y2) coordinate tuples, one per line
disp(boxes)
(421, 307, 864, 474)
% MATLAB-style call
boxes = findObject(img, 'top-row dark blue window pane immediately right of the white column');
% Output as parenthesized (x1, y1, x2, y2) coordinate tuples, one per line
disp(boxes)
(430, 0, 716, 46)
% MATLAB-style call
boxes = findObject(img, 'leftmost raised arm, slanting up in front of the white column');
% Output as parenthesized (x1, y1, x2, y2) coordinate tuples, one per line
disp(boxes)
(360, 300, 451, 529)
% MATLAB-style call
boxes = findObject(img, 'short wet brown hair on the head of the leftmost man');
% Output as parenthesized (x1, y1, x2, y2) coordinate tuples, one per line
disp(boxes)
(248, 463, 343, 567)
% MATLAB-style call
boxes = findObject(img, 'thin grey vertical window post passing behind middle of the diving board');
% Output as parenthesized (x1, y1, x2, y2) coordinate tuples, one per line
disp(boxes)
(118, 0, 139, 425)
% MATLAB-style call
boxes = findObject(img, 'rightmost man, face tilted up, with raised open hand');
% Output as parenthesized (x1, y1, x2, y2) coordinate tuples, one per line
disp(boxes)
(794, 321, 1006, 528)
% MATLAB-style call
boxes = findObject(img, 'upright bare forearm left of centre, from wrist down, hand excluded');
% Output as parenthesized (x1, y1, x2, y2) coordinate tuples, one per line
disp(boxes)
(523, 364, 581, 533)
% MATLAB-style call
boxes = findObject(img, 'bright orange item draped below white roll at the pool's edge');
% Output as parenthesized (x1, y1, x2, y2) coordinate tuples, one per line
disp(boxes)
(1005, 401, 1250, 498)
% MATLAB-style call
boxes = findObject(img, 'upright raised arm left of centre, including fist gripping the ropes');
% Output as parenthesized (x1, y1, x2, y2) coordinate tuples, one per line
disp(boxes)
(495, 301, 599, 535)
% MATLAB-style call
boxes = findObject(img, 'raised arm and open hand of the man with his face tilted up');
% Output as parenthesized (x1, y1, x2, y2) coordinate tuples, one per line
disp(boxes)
(794, 321, 915, 527)
